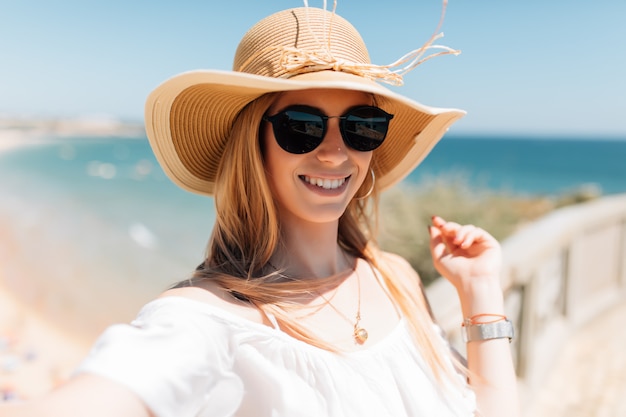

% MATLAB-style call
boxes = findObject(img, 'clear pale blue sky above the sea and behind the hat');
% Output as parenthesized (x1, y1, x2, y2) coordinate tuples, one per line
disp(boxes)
(0, 0, 626, 138)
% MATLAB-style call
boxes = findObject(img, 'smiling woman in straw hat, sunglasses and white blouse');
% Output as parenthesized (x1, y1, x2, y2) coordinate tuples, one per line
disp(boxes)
(0, 4, 517, 417)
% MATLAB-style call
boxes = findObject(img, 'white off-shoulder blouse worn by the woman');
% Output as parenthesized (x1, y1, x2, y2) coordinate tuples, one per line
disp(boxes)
(77, 297, 476, 417)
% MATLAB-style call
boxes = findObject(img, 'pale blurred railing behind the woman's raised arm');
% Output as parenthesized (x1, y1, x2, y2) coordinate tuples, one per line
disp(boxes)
(427, 195, 626, 402)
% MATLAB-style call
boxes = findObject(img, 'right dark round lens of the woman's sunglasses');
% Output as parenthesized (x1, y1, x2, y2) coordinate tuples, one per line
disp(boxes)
(343, 107, 393, 152)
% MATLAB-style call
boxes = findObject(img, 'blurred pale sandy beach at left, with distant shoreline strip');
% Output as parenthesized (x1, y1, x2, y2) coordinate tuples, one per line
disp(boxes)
(0, 126, 163, 401)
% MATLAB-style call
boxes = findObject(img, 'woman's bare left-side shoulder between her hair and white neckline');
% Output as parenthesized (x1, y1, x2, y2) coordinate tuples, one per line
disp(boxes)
(159, 282, 265, 323)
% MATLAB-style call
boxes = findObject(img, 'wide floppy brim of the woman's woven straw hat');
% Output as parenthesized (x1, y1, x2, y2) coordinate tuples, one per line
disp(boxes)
(145, 70, 465, 195)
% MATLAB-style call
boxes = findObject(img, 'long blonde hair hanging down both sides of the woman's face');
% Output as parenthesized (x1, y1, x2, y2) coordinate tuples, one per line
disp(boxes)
(178, 93, 458, 381)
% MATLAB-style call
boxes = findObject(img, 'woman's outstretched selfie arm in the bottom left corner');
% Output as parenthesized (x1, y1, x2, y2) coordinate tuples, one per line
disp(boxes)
(0, 374, 152, 417)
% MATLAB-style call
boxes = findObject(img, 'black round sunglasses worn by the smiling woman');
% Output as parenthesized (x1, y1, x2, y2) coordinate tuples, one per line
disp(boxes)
(263, 105, 393, 154)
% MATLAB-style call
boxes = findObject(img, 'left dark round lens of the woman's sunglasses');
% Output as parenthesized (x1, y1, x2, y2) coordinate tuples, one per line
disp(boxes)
(274, 110, 324, 153)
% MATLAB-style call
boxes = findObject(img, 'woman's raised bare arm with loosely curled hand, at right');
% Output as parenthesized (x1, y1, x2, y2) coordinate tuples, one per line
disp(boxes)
(430, 216, 520, 417)
